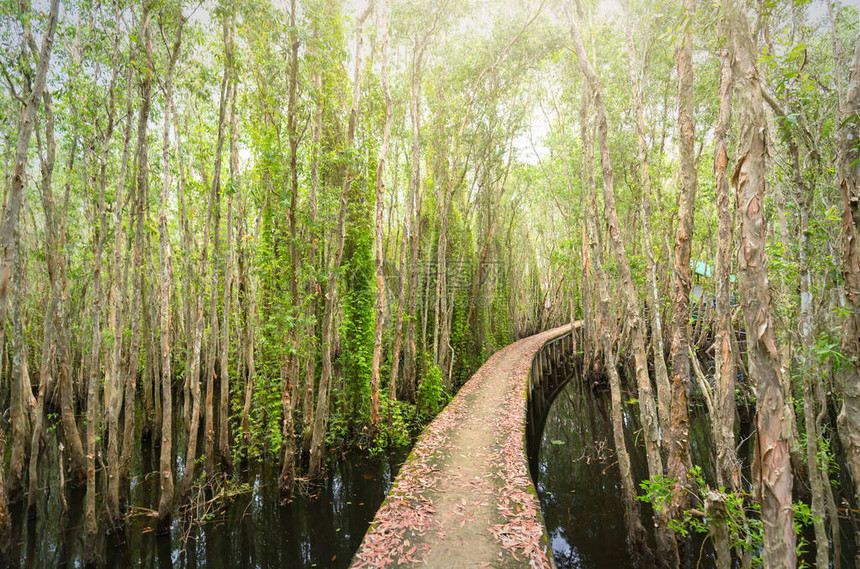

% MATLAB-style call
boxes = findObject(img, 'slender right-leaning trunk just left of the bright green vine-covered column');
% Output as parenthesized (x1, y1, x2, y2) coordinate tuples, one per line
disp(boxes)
(308, 0, 373, 479)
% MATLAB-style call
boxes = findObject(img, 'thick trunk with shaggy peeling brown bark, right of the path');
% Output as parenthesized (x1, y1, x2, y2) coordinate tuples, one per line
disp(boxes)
(727, 3, 797, 568)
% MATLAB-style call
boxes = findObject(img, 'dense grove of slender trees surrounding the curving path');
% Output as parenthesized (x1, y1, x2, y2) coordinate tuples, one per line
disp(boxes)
(0, 0, 860, 567)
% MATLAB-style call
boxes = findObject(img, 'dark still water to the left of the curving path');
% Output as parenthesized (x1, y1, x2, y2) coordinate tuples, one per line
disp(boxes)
(5, 448, 409, 569)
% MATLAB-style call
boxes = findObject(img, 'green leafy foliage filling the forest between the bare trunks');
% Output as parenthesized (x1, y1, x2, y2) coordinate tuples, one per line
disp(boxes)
(6, 0, 857, 547)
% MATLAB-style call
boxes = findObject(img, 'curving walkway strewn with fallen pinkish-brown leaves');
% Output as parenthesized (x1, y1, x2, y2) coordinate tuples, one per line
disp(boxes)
(352, 325, 570, 569)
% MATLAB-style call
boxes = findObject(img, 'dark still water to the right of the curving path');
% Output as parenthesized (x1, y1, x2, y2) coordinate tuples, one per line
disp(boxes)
(529, 373, 857, 569)
